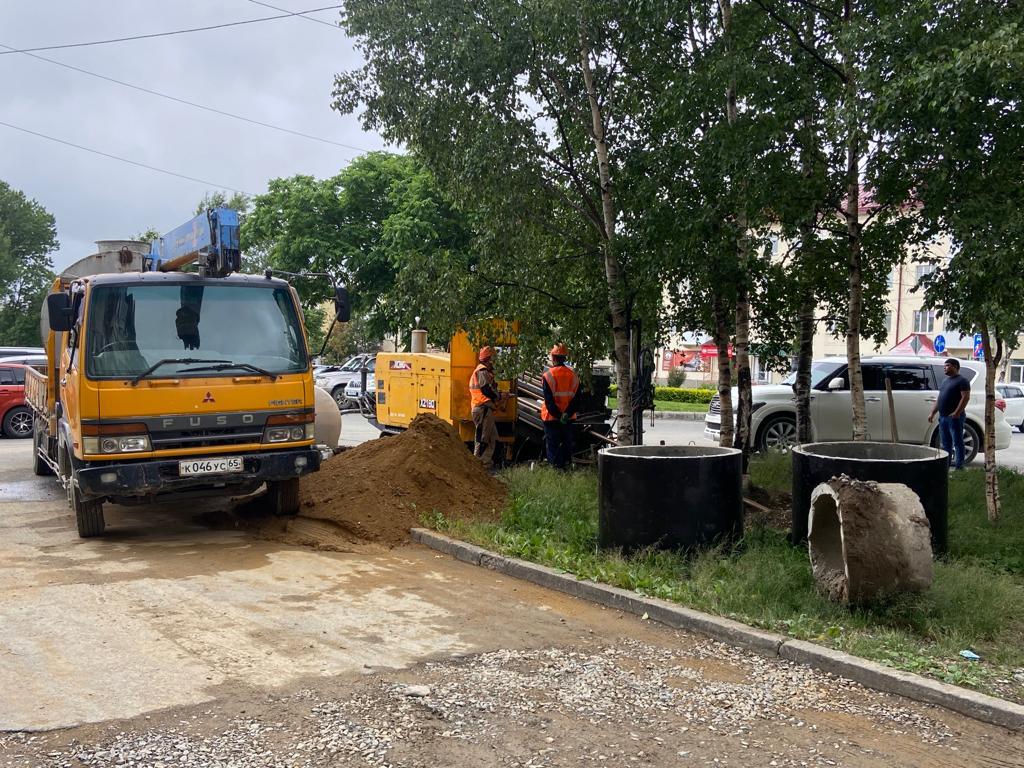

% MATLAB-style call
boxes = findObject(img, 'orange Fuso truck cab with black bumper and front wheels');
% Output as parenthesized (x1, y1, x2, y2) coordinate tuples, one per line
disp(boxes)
(26, 207, 347, 537)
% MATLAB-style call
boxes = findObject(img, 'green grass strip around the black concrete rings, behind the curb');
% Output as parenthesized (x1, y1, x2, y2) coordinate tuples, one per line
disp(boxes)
(428, 457, 1024, 698)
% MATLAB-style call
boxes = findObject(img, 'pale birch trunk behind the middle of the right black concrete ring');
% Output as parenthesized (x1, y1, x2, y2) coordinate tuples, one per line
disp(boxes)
(843, 7, 867, 440)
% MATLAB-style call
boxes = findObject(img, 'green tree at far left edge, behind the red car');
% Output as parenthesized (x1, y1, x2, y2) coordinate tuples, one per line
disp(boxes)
(0, 181, 57, 346)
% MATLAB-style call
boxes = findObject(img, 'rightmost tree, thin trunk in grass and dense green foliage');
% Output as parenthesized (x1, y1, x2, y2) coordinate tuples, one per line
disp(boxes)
(876, 0, 1024, 519)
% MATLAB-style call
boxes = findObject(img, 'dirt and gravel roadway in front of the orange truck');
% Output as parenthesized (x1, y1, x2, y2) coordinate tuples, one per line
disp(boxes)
(0, 440, 1024, 767)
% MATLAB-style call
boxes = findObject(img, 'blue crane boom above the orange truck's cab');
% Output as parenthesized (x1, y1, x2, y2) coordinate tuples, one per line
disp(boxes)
(145, 208, 242, 278)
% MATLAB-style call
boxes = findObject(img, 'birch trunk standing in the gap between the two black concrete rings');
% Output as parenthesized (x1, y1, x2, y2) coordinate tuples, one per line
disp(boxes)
(718, 0, 754, 475)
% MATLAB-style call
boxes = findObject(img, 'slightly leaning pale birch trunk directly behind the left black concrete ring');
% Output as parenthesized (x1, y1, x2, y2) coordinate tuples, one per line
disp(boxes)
(580, 34, 634, 445)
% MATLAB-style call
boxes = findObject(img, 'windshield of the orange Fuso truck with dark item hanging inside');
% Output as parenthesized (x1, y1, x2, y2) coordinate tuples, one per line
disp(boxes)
(85, 283, 308, 379)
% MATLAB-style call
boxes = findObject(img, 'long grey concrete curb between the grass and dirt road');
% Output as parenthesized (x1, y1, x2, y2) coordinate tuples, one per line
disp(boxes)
(411, 528, 1024, 731)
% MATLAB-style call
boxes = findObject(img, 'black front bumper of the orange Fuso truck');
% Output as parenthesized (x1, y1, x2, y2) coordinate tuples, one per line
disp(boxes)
(75, 447, 321, 499)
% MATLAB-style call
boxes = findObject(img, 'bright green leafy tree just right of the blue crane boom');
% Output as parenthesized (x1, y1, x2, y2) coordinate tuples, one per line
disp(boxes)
(242, 153, 477, 346)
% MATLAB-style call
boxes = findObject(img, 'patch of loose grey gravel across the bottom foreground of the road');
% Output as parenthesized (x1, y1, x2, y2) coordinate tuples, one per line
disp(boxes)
(0, 640, 987, 768)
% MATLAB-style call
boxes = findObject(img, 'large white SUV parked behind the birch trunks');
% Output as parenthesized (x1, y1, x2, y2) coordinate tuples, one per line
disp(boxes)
(705, 356, 1010, 462)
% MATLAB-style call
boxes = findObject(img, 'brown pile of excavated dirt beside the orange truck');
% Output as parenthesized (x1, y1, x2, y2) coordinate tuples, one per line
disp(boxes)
(284, 414, 505, 548)
